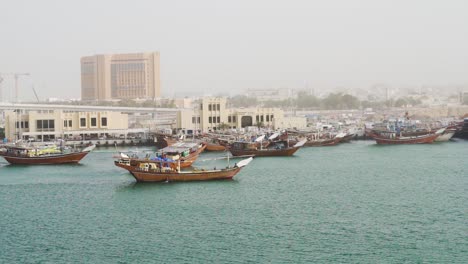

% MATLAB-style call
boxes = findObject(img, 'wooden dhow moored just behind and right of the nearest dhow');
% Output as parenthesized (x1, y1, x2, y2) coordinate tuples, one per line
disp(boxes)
(229, 139, 307, 157)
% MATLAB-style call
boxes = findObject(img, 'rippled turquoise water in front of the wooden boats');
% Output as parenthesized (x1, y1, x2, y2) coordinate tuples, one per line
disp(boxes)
(0, 141, 468, 263)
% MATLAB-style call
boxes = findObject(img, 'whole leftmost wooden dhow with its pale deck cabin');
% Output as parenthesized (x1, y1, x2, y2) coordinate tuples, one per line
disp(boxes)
(0, 145, 96, 165)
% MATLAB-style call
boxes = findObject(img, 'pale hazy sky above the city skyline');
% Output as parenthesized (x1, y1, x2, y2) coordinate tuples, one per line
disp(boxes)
(0, 0, 468, 100)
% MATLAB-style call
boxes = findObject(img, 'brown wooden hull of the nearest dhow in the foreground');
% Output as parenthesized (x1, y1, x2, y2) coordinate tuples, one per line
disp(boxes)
(115, 162, 241, 182)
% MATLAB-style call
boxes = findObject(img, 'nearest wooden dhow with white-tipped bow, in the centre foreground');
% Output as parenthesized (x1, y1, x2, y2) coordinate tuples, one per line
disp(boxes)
(114, 157, 252, 182)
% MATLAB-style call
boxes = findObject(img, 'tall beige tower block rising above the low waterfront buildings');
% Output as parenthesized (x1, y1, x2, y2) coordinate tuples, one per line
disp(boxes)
(81, 52, 161, 100)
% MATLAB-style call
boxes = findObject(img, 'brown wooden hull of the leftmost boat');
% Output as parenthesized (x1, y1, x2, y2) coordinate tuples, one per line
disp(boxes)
(1, 152, 89, 165)
